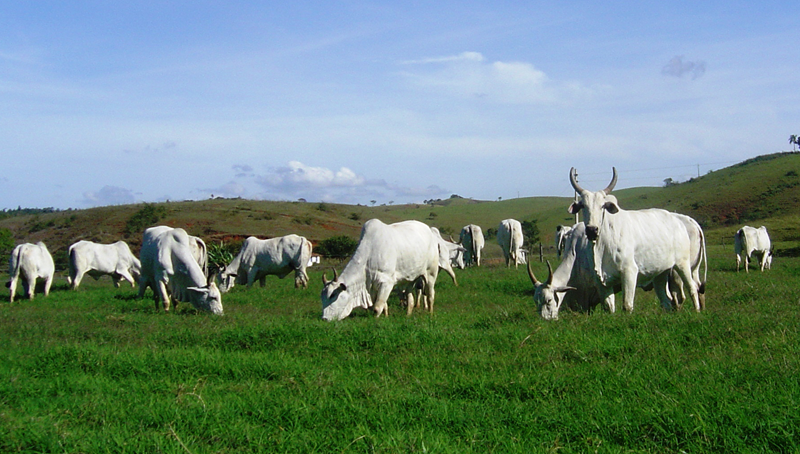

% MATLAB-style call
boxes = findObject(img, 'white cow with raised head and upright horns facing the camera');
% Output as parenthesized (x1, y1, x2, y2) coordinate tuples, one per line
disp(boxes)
(569, 168, 701, 312)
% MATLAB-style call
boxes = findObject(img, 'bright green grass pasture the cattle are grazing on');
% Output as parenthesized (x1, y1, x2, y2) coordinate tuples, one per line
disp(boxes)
(0, 245, 800, 454)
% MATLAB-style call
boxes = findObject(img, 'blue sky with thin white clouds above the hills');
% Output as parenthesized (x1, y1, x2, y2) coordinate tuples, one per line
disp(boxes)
(0, 0, 800, 208)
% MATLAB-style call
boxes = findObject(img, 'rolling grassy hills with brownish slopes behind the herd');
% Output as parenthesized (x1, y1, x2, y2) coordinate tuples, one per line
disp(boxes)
(0, 153, 800, 261)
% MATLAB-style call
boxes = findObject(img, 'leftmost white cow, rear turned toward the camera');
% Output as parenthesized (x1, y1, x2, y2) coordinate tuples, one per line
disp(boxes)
(6, 241, 56, 303)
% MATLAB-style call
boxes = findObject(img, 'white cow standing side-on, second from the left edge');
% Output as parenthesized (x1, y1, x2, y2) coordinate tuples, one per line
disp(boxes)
(67, 240, 142, 290)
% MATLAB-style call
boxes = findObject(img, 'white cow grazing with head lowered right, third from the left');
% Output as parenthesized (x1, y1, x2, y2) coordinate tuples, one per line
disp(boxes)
(139, 226, 222, 315)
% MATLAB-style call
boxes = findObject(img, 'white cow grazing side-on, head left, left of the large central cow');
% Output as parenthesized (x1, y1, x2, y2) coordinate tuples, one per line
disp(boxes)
(219, 234, 312, 292)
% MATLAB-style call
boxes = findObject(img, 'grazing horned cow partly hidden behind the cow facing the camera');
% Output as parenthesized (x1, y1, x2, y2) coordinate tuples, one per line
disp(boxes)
(528, 222, 614, 320)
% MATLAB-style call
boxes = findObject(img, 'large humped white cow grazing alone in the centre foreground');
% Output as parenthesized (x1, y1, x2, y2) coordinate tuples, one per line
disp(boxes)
(320, 219, 439, 321)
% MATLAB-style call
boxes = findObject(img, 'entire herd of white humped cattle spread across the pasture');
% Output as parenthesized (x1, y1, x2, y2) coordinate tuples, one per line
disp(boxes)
(6, 168, 772, 320)
